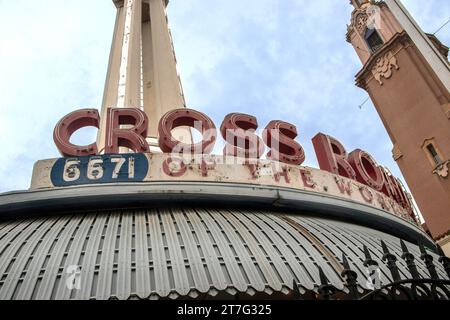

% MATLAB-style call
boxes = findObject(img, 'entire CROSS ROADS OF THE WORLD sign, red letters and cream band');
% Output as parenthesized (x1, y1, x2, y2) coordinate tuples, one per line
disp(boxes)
(32, 108, 414, 224)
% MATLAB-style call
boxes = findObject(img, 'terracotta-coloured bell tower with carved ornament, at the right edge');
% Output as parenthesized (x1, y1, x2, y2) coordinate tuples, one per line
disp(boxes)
(347, 0, 450, 255)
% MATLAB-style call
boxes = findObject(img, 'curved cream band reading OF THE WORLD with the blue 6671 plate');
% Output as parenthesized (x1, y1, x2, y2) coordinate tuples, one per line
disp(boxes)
(32, 153, 412, 221)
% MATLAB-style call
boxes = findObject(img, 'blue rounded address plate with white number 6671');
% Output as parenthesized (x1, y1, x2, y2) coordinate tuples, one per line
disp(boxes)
(51, 153, 149, 187)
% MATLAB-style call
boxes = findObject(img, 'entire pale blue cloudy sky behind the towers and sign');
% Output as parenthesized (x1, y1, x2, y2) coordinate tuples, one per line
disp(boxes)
(0, 0, 450, 192)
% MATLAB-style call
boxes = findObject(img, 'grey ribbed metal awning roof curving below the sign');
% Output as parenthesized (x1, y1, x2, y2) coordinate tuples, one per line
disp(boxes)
(0, 208, 446, 299)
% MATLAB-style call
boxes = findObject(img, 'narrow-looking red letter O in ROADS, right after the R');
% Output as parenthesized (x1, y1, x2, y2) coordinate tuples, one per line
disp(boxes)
(348, 149, 384, 191)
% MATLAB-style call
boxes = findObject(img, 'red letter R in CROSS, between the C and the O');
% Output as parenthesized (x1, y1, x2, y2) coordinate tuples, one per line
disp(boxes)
(105, 108, 150, 154)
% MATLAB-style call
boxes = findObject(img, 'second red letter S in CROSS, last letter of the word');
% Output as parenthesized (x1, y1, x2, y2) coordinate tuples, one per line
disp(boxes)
(263, 121, 305, 165)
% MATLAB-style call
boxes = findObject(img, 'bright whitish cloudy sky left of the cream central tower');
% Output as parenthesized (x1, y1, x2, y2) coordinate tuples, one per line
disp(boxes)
(0, 0, 114, 191)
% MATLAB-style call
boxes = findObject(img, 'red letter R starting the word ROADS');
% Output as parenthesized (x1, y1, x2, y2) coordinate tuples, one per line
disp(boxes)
(312, 133, 356, 180)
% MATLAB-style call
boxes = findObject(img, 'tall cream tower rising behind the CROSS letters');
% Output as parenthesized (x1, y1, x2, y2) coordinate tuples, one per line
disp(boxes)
(98, 0, 192, 152)
